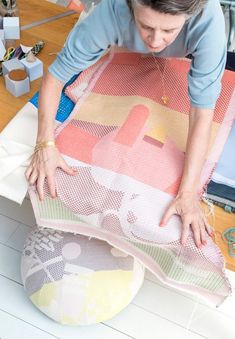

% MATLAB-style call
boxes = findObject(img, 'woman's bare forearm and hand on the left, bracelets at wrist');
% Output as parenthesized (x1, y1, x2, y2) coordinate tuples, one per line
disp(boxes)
(25, 72, 75, 200)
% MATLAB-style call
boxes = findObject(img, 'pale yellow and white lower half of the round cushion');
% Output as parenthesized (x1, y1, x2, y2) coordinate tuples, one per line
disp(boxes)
(30, 270, 140, 325)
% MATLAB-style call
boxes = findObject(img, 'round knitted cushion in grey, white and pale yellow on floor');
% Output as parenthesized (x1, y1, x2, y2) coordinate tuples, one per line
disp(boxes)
(21, 227, 144, 325)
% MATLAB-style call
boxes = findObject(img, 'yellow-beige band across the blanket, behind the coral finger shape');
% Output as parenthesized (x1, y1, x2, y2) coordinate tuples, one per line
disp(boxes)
(74, 93, 220, 152)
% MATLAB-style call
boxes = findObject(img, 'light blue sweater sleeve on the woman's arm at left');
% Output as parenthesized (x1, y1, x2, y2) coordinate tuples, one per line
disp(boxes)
(48, 0, 121, 83)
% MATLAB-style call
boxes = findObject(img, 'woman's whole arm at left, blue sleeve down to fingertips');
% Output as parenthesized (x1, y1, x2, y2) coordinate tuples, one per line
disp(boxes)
(25, 0, 121, 199)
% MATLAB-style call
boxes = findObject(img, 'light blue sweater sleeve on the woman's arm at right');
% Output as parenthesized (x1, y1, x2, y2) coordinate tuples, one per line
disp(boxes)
(188, 1, 227, 109)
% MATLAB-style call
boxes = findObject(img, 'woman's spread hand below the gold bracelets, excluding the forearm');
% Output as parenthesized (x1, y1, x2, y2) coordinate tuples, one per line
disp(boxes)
(25, 146, 76, 200)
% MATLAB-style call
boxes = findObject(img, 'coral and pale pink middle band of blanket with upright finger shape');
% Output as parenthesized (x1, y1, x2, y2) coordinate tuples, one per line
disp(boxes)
(56, 105, 184, 193)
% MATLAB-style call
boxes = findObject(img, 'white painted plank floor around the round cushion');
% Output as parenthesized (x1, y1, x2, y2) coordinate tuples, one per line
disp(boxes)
(0, 198, 235, 339)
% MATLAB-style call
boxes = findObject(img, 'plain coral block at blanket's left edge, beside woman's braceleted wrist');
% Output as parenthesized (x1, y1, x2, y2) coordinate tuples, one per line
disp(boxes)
(56, 123, 99, 164)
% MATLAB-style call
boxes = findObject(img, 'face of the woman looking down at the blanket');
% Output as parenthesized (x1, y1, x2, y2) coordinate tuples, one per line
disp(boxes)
(134, 5, 186, 52)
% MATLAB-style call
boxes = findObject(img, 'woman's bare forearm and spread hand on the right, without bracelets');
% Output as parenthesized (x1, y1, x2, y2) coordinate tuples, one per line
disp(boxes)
(160, 107, 213, 248)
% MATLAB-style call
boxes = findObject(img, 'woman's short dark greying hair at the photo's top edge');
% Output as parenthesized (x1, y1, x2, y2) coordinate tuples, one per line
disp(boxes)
(126, 0, 208, 16)
